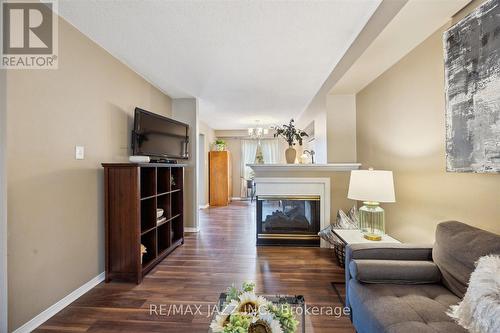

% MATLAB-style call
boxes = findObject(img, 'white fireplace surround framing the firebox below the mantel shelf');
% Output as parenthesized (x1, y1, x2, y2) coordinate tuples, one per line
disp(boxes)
(255, 177, 331, 247)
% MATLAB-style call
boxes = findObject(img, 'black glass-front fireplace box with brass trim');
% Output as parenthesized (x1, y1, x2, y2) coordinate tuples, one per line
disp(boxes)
(257, 195, 321, 246)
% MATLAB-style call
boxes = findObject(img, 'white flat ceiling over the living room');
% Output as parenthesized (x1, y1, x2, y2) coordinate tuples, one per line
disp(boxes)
(59, 0, 380, 129)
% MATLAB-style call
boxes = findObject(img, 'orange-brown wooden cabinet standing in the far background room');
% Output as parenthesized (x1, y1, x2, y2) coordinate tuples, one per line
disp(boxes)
(208, 151, 233, 206)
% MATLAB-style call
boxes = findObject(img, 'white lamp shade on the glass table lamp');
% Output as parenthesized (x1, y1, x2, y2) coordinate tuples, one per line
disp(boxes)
(347, 170, 396, 202)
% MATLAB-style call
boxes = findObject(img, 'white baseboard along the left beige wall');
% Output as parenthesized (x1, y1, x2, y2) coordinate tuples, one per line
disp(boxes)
(13, 272, 105, 333)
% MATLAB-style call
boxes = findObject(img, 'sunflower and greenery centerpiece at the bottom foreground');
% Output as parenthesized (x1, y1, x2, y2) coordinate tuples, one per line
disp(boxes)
(210, 282, 299, 333)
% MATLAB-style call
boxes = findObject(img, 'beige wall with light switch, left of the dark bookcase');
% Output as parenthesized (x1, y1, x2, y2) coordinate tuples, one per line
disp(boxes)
(7, 16, 171, 330)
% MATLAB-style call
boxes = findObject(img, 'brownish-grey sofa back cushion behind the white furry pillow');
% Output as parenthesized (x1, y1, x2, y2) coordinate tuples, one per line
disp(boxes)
(432, 221, 500, 298)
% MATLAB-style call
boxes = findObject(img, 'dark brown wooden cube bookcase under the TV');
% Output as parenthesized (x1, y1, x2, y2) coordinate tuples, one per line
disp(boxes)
(103, 163, 184, 284)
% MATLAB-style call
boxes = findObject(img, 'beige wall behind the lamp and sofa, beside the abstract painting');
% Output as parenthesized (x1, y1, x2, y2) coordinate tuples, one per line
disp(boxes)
(356, 1, 500, 243)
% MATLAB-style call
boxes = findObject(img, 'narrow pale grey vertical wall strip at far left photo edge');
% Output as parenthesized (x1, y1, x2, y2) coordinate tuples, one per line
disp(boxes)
(0, 65, 8, 333)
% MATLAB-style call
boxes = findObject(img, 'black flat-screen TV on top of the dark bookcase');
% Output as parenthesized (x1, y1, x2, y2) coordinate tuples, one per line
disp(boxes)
(132, 108, 189, 159)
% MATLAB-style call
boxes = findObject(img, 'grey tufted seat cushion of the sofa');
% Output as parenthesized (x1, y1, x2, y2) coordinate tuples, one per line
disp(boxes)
(348, 279, 467, 333)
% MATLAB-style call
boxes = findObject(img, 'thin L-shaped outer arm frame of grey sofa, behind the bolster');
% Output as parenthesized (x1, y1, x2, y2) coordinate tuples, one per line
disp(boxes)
(345, 243, 432, 306)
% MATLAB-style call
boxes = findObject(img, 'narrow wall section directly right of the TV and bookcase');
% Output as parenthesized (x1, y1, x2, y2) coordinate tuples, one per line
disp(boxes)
(172, 98, 199, 231)
